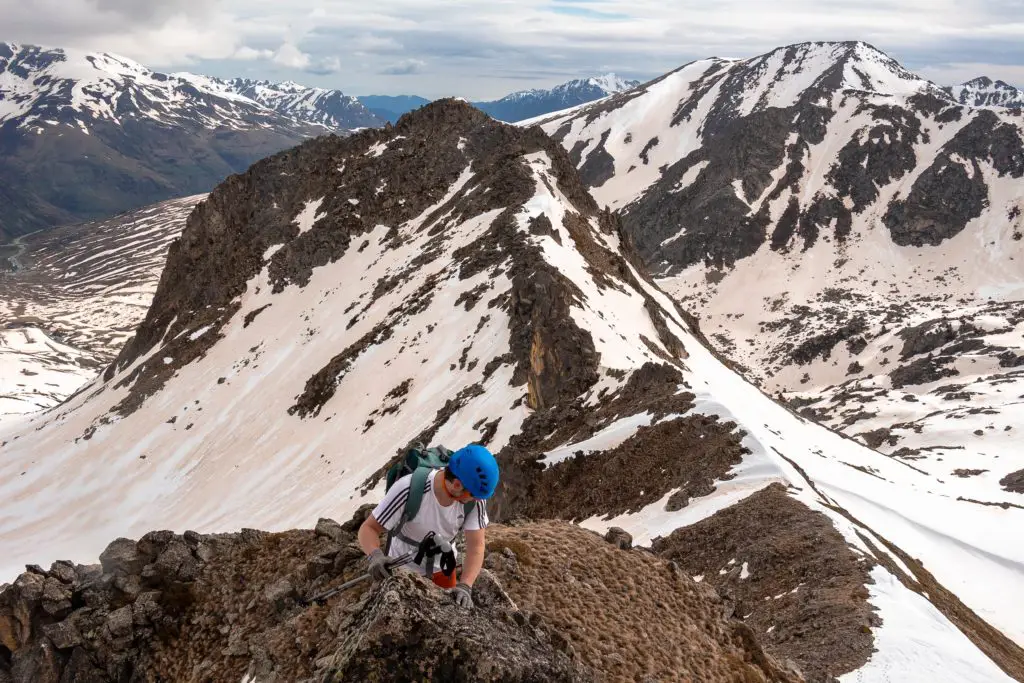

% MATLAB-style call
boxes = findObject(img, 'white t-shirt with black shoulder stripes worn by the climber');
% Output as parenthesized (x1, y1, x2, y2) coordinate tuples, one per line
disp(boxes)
(373, 470, 487, 573)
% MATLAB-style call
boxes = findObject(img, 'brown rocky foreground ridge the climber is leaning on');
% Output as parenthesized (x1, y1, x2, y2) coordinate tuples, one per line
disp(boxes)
(0, 515, 798, 683)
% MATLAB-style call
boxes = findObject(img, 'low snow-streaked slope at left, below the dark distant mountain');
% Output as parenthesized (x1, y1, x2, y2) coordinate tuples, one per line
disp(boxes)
(0, 197, 202, 423)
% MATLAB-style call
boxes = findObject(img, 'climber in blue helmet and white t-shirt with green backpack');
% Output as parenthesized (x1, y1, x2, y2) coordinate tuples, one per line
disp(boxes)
(358, 444, 499, 607)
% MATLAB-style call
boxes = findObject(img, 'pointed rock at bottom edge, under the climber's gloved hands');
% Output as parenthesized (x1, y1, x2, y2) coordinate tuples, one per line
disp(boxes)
(314, 571, 597, 683)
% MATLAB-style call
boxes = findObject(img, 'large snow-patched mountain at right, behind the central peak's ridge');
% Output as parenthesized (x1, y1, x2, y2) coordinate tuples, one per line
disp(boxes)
(544, 43, 1024, 505)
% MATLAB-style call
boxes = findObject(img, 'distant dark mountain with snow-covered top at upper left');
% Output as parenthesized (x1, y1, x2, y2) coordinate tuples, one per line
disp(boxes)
(0, 43, 332, 240)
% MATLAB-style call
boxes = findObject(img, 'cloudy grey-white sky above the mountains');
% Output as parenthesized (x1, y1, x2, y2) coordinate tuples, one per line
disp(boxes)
(0, 0, 1024, 99)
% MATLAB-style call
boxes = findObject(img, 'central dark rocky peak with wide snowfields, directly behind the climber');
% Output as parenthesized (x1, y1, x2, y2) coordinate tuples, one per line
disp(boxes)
(0, 100, 1024, 681)
